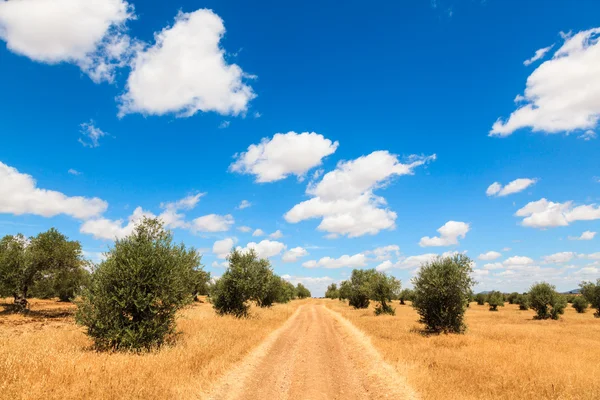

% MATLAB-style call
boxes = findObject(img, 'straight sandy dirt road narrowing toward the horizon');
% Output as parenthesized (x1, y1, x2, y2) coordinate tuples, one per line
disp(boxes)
(203, 304, 417, 400)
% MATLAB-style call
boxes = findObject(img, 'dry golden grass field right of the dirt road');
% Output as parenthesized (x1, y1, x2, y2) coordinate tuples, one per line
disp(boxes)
(323, 300, 600, 400)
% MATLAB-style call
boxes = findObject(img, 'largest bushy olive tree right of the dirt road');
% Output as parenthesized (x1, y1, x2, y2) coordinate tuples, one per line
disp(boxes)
(412, 254, 475, 333)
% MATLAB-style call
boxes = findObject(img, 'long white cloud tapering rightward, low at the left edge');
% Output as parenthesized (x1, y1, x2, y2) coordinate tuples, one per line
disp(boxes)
(0, 162, 108, 219)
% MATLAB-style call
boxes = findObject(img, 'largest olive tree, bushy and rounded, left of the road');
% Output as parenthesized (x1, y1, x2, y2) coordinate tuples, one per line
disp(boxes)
(76, 218, 200, 351)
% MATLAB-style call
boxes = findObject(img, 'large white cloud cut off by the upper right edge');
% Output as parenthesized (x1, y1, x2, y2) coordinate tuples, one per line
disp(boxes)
(490, 28, 600, 136)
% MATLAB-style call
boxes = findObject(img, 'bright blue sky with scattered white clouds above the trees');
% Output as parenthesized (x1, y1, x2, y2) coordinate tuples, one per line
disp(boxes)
(0, 0, 600, 295)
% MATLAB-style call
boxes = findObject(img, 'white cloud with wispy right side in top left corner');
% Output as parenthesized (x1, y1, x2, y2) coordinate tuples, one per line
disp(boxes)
(0, 0, 135, 82)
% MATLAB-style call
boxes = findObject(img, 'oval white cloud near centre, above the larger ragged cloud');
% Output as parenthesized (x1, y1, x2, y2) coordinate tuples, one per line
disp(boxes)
(230, 132, 338, 183)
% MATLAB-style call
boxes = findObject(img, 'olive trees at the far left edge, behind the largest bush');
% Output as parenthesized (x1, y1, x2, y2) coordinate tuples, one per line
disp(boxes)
(0, 229, 90, 310)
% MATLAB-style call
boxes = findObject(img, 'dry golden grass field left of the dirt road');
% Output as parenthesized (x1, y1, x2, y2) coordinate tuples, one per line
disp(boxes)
(0, 300, 304, 400)
